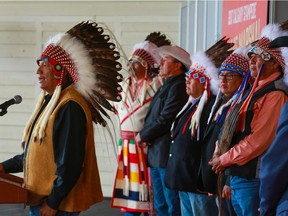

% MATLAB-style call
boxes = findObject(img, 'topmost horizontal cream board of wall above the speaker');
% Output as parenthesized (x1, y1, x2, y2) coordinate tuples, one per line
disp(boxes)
(0, 1, 179, 16)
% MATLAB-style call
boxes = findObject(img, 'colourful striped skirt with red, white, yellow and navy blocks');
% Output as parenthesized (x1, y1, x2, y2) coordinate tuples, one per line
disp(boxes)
(111, 131, 150, 212)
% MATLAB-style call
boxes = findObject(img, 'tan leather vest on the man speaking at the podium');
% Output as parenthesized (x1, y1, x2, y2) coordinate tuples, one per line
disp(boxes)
(24, 86, 103, 212)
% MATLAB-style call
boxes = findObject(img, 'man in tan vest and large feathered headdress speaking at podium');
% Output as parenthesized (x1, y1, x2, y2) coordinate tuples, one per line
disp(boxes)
(0, 22, 120, 216)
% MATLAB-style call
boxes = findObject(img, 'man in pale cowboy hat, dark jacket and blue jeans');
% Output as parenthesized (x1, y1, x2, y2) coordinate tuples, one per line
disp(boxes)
(135, 46, 191, 216)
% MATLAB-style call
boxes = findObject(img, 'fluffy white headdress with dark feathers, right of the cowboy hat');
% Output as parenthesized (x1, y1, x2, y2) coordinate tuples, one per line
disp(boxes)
(186, 37, 234, 136)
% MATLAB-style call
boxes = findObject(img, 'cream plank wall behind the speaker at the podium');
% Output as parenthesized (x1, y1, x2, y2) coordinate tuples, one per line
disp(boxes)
(0, 0, 181, 197)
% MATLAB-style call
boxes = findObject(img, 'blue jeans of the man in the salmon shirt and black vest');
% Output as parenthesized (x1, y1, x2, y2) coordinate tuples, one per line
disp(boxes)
(230, 176, 260, 216)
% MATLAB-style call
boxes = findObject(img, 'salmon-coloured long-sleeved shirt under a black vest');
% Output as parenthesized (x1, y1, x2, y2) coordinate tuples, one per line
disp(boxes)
(220, 72, 288, 167)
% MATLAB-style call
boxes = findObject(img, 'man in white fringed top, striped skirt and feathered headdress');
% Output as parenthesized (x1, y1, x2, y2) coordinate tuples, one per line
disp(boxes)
(111, 32, 170, 215)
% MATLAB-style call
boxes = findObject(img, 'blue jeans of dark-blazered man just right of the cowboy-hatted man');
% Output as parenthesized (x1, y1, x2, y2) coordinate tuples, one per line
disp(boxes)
(179, 191, 218, 216)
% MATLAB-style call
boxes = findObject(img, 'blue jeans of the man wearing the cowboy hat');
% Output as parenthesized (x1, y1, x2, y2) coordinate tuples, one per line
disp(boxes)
(150, 168, 181, 216)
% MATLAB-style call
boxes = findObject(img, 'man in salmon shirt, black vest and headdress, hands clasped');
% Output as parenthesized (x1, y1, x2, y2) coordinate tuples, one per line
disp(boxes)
(210, 21, 288, 216)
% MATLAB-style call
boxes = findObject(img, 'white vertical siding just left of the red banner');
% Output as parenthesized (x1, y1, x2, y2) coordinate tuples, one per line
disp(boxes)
(180, 0, 222, 54)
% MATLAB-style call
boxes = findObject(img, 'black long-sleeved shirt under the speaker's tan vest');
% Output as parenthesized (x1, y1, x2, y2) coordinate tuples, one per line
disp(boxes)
(3, 96, 86, 209)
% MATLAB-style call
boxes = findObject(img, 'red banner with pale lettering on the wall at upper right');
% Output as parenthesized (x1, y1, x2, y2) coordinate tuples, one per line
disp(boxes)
(222, 0, 268, 48)
